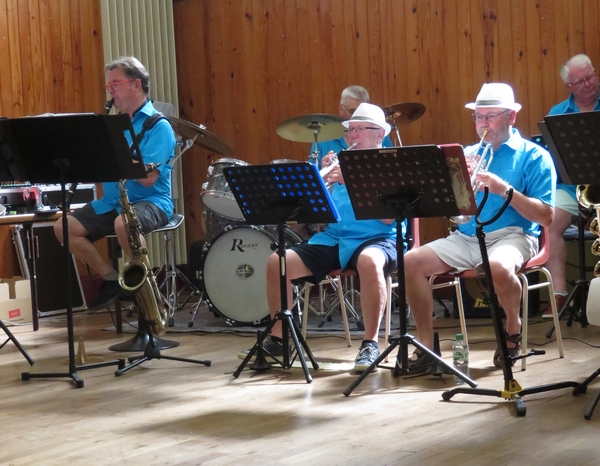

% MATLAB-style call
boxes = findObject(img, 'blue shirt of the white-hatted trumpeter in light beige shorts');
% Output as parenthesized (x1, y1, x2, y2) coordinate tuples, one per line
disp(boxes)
(458, 128, 556, 236)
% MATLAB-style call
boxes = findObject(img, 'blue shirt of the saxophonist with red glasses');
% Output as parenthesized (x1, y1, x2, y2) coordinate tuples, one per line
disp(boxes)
(91, 100, 175, 218)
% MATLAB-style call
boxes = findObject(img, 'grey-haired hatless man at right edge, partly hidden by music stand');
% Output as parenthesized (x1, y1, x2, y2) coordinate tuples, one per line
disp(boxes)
(542, 54, 600, 319)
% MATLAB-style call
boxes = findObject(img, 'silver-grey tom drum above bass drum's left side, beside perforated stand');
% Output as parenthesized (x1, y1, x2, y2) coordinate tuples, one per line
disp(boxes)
(200, 159, 250, 220)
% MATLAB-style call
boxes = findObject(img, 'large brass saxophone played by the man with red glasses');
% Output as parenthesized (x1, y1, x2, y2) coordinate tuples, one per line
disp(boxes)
(119, 180, 169, 335)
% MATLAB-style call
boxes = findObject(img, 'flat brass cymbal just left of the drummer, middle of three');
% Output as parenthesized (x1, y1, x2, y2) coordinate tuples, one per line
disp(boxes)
(277, 113, 345, 142)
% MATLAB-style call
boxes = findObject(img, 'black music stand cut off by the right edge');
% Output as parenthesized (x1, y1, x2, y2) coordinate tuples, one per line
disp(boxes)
(538, 112, 600, 332)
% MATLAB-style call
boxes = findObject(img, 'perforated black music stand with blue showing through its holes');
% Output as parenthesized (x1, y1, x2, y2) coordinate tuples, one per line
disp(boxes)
(224, 162, 339, 383)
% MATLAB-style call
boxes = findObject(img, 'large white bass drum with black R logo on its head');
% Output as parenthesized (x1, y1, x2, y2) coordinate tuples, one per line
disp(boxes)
(201, 226, 301, 325)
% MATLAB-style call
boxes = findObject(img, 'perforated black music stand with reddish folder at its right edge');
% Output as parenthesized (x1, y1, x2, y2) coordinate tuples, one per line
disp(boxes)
(338, 145, 477, 396)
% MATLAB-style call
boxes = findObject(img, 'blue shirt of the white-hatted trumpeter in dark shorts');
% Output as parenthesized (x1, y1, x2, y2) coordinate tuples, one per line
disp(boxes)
(308, 183, 406, 268)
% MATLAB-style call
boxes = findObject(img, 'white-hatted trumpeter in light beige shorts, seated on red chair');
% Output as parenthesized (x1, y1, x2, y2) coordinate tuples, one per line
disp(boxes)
(405, 83, 556, 369)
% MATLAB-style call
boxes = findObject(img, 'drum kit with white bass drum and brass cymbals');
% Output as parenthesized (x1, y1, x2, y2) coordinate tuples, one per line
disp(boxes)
(169, 102, 425, 326)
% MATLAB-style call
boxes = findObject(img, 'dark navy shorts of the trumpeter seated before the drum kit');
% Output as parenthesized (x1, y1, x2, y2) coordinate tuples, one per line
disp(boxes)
(290, 238, 397, 284)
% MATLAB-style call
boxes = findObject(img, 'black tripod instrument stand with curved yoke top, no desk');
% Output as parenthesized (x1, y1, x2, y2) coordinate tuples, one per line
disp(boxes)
(442, 186, 579, 416)
